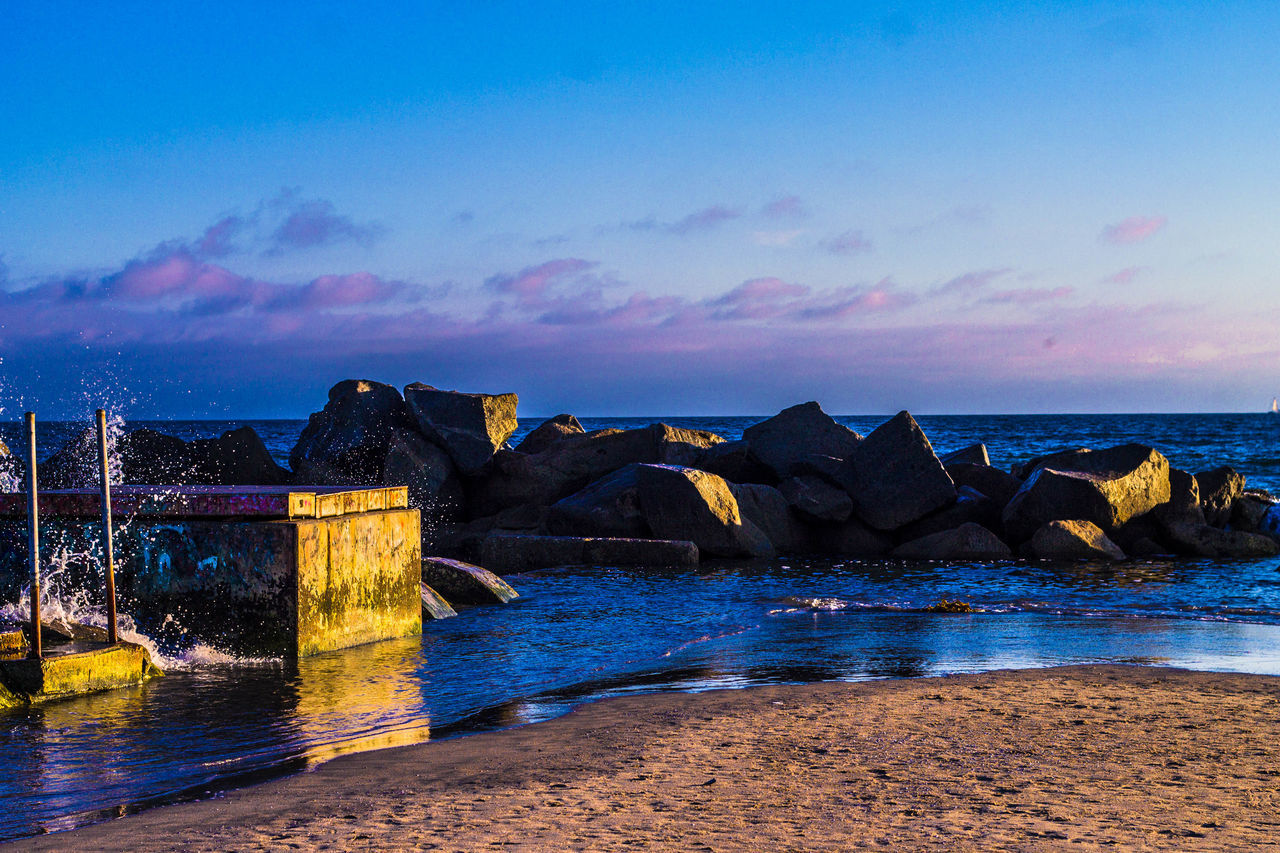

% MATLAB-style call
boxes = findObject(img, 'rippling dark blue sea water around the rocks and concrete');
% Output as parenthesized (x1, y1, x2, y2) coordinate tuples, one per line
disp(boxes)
(0, 412, 1280, 840)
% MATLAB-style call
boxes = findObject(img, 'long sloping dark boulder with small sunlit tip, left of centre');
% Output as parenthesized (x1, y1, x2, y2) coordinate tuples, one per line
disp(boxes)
(467, 424, 723, 516)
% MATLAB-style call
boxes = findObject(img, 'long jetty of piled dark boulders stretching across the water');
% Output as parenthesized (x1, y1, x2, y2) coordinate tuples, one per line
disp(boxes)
(30, 379, 1280, 571)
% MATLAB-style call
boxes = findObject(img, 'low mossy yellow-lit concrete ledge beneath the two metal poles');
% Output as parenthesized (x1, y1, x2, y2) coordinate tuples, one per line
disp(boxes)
(0, 643, 164, 707)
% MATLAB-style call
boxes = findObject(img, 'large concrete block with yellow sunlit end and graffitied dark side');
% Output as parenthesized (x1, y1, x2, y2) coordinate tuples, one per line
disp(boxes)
(0, 485, 422, 656)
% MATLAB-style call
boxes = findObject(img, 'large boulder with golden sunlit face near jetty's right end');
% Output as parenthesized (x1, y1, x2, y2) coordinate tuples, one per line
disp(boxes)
(1004, 444, 1170, 542)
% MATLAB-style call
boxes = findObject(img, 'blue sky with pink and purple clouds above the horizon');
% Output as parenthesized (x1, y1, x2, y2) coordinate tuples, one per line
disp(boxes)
(0, 3, 1280, 418)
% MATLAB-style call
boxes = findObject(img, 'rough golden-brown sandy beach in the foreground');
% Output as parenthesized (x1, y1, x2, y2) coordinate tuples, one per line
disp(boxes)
(14, 666, 1280, 850)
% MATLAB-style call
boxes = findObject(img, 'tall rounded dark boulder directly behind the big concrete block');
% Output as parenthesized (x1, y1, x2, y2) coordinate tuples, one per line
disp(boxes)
(289, 379, 415, 485)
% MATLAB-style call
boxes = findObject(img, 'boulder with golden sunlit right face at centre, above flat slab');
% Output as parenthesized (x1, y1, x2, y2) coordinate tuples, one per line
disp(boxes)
(635, 465, 774, 557)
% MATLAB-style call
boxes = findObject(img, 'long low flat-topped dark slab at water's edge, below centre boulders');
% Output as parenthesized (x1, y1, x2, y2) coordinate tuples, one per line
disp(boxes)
(480, 534, 699, 573)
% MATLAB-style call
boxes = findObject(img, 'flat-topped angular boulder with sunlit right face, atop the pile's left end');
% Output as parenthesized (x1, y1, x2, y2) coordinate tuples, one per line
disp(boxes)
(404, 382, 518, 474)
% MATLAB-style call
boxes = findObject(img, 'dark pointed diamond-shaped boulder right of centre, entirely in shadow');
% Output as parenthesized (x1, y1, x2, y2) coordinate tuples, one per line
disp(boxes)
(841, 411, 956, 530)
